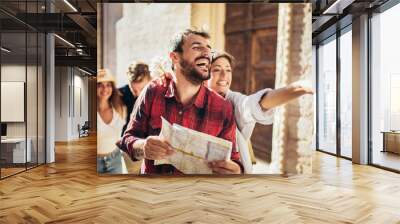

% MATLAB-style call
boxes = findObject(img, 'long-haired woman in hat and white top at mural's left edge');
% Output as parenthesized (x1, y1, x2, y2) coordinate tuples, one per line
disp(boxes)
(97, 69, 126, 174)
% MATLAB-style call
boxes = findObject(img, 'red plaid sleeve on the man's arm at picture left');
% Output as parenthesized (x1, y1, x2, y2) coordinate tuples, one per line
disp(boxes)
(117, 84, 152, 161)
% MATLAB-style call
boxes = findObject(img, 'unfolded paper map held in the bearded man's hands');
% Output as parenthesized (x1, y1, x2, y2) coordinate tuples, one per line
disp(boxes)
(154, 117, 232, 174)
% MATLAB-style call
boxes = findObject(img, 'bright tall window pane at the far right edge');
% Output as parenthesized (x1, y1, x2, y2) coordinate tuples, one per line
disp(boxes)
(370, 1, 400, 170)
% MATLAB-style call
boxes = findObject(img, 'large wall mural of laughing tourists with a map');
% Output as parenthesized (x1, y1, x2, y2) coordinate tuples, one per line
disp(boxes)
(97, 3, 314, 175)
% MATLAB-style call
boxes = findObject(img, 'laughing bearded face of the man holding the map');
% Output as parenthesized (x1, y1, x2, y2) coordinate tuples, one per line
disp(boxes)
(172, 34, 211, 85)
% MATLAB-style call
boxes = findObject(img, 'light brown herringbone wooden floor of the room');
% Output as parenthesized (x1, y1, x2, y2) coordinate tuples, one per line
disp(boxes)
(0, 134, 400, 224)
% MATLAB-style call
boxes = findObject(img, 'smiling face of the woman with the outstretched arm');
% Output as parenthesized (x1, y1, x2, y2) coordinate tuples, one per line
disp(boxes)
(208, 57, 232, 96)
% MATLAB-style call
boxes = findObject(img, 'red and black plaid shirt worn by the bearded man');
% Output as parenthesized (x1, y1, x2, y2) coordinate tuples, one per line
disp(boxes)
(117, 80, 242, 174)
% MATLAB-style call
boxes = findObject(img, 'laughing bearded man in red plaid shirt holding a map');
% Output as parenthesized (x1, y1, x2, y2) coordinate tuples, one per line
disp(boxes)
(118, 29, 243, 174)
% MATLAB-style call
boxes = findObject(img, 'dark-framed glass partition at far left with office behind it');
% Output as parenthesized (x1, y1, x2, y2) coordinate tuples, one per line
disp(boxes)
(0, 1, 46, 179)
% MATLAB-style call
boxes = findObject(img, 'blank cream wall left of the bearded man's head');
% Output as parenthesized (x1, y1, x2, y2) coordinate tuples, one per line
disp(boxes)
(114, 3, 191, 86)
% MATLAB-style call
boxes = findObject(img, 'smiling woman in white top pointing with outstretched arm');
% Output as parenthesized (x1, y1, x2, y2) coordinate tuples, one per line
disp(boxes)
(208, 52, 313, 173)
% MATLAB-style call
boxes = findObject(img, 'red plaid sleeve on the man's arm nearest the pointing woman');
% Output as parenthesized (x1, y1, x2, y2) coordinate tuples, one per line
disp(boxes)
(219, 103, 244, 173)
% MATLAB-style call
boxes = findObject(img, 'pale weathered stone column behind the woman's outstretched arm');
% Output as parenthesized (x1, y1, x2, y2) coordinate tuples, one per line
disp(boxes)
(271, 3, 314, 174)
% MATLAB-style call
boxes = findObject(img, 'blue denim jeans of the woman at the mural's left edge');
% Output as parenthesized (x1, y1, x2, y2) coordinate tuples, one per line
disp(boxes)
(97, 149, 122, 174)
